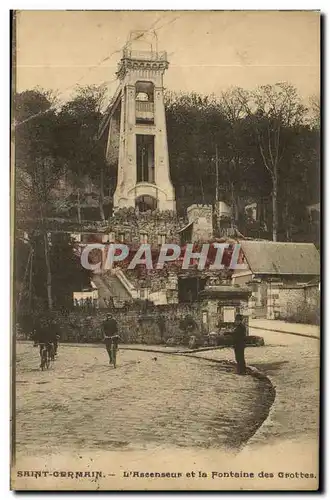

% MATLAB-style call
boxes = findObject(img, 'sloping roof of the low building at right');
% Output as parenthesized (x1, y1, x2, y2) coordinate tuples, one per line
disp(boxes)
(240, 241, 320, 276)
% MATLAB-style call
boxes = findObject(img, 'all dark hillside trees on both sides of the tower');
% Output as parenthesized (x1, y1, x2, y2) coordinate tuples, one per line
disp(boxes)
(12, 83, 320, 303)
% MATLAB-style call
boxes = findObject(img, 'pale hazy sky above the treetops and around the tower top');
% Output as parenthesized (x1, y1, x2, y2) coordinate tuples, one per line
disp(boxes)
(16, 10, 320, 102)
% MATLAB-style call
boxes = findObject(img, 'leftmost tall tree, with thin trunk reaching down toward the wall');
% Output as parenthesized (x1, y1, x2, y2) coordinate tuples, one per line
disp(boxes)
(14, 89, 63, 309)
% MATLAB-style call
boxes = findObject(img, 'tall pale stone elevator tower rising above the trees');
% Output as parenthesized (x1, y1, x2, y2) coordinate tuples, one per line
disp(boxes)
(107, 32, 175, 211)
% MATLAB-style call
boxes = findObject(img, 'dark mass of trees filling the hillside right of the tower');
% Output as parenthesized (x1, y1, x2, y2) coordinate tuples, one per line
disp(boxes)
(165, 83, 320, 241)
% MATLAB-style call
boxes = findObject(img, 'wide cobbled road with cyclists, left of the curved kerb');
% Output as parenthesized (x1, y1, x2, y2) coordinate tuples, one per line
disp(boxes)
(16, 343, 268, 455)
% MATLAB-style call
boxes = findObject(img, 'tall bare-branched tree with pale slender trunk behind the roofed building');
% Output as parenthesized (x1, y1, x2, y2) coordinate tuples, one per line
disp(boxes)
(239, 83, 306, 241)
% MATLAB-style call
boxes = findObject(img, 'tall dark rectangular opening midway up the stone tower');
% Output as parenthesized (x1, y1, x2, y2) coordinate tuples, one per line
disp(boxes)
(136, 134, 155, 183)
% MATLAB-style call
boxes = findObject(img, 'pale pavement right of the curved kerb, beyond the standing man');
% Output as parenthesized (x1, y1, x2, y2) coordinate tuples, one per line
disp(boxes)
(192, 325, 320, 444)
